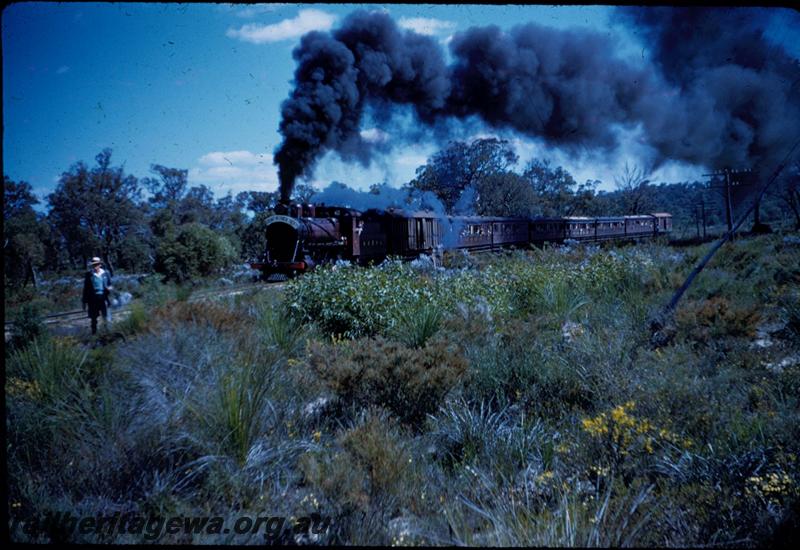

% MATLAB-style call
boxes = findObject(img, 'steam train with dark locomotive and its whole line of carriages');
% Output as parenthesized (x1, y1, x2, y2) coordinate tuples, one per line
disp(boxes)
(250, 204, 672, 279)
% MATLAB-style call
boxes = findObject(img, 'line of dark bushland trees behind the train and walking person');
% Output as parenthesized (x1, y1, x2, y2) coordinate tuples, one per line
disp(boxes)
(3, 138, 800, 288)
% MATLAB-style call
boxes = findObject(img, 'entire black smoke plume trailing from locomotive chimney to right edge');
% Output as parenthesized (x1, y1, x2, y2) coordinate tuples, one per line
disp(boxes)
(275, 8, 800, 201)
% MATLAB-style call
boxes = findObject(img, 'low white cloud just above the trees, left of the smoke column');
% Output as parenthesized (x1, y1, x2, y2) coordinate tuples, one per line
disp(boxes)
(189, 151, 278, 196)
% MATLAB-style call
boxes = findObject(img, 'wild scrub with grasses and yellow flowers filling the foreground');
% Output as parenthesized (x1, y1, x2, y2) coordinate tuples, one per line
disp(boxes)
(5, 234, 800, 546)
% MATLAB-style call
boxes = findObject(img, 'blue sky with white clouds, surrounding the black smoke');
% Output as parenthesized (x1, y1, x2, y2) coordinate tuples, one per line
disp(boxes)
(2, 2, 800, 205)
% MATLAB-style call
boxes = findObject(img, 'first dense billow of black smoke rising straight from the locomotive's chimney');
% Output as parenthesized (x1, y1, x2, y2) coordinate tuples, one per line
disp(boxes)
(275, 11, 449, 201)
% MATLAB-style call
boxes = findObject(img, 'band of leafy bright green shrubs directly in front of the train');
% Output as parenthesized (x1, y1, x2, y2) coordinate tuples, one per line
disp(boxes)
(286, 251, 652, 342)
